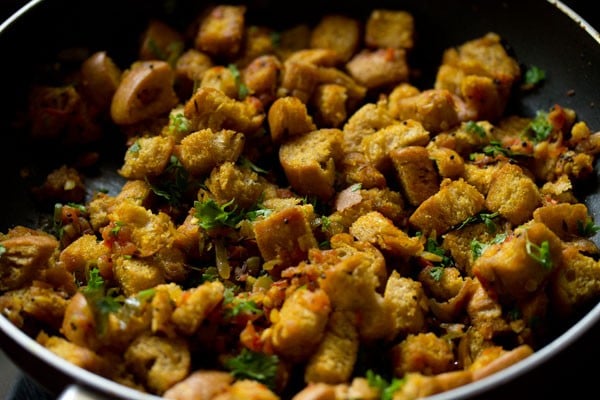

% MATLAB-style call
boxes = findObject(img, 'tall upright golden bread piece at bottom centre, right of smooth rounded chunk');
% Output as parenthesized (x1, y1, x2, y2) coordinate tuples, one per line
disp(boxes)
(304, 311, 359, 384)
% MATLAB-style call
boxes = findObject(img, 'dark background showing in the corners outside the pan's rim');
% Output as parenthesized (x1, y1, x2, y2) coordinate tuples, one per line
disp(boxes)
(0, 0, 600, 400)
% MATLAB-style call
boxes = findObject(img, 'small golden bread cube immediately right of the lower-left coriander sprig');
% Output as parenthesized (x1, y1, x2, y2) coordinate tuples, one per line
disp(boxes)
(113, 257, 165, 296)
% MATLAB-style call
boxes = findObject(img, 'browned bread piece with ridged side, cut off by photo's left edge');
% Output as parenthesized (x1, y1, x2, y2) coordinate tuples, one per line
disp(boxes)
(0, 227, 59, 291)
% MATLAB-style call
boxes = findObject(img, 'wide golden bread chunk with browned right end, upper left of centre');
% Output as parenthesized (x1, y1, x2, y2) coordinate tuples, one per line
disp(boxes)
(175, 129, 246, 176)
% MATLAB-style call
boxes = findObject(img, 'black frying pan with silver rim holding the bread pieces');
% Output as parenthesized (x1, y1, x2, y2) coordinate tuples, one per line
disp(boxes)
(0, 0, 600, 400)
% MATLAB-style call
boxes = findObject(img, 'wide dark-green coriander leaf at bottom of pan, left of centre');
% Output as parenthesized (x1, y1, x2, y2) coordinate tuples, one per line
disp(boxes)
(225, 348, 279, 389)
